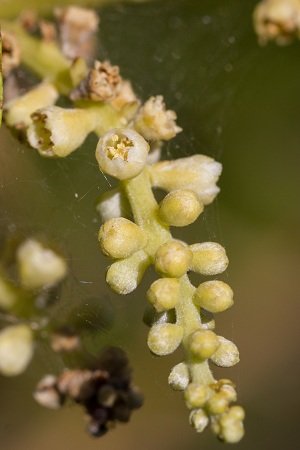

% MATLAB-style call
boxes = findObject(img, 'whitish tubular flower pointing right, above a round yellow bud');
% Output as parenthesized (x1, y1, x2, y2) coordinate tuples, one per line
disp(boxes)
(148, 155, 222, 205)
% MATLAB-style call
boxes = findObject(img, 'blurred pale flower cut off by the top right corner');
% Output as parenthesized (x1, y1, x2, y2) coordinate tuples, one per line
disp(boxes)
(253, 0, 300, 45)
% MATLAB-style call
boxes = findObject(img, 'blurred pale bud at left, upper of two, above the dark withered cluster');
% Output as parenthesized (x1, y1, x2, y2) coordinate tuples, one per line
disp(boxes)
(17, 239, 67, 289)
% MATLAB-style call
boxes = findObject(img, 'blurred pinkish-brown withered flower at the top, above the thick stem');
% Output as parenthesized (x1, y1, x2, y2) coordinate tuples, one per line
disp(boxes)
(54, 6, 99, 59)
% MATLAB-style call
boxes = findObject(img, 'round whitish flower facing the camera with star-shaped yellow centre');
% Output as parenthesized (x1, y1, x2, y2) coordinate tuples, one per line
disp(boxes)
(96, 128, 149, 180)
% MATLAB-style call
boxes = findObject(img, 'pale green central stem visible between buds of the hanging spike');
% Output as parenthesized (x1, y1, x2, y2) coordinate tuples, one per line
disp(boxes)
(122, 170, 215, 385)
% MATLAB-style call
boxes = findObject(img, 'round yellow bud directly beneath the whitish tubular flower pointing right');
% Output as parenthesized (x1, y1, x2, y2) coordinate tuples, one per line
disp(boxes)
(158, 189, 204, 227)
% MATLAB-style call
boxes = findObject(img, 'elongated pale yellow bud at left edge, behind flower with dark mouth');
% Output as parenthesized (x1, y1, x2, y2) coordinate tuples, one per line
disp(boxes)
(4, 82, 58, 129)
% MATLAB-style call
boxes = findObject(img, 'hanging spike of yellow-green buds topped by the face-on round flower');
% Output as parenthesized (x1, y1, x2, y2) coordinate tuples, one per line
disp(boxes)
(96, 125, 244, 443)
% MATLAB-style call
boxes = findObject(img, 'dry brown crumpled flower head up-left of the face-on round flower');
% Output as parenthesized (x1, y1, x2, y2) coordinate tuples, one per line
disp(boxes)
(70, 61, 122, 102)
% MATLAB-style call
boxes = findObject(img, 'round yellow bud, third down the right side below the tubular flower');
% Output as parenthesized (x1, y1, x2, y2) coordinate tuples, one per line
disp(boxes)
(194, 280, 233, 313)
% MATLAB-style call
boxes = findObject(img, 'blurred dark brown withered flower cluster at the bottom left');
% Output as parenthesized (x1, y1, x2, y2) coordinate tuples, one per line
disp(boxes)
(34, 347, 143, 437)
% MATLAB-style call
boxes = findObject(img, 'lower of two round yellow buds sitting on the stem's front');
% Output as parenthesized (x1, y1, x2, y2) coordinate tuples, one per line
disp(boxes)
(189, 330, 220, 359)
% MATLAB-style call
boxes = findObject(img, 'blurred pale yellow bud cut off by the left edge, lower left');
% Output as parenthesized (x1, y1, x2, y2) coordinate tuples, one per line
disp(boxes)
(0, 325, 33, 376)
